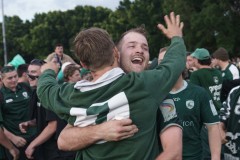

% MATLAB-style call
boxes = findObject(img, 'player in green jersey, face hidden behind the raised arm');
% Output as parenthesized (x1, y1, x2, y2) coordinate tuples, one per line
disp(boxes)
(158, 47, 221, 160)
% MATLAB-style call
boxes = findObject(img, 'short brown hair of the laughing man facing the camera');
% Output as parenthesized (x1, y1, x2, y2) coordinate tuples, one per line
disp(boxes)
(117, 25, 148, 50)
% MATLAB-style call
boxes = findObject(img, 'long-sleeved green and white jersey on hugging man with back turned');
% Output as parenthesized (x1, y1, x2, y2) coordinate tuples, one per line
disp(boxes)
(37, 37, 186, 160)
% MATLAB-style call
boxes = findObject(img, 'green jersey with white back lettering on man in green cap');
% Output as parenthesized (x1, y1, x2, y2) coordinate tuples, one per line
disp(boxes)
(190, 68, 223, 111)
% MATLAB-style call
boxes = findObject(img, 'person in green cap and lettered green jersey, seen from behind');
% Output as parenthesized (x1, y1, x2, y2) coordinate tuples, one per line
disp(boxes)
(190, 48, 223, 159)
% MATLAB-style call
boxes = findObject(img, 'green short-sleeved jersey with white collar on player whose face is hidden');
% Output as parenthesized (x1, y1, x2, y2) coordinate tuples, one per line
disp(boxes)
(161, 81, 219, 160)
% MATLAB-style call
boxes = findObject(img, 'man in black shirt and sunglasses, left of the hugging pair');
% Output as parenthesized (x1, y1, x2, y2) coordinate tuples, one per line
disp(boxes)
(19, 59, 74, 160)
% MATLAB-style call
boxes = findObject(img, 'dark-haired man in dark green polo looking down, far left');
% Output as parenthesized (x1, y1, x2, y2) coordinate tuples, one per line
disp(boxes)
(0, 66, 35, 160)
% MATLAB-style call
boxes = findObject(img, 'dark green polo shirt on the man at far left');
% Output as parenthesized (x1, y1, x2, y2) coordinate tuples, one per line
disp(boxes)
(0, 83, 35, 138)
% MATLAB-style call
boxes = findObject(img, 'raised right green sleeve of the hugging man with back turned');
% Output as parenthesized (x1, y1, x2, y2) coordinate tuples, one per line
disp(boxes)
(143, 37, 186, 101)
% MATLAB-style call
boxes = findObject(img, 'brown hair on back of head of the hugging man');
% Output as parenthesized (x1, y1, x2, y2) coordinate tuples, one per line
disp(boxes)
(74, 28, 115, 71)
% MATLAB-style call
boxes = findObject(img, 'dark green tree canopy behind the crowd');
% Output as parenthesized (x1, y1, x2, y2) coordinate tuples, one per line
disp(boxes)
(0, 0, 240, 65)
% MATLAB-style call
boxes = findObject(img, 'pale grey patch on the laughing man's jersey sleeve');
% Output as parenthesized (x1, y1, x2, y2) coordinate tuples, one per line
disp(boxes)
(159, 99, 177, 122)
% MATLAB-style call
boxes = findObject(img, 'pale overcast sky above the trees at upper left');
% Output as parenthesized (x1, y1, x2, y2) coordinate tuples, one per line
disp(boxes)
(0, 0, 120, 21)
